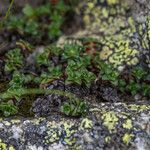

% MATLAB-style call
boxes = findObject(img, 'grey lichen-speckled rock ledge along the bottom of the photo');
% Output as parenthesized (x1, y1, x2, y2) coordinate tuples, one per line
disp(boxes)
(0, 103, 150, 150)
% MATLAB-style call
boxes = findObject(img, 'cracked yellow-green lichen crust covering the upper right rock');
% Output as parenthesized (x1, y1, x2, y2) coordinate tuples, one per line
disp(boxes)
(74, 0, 148, 68)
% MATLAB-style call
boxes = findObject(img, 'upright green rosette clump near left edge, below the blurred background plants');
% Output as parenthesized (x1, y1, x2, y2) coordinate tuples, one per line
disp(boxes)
(5, 48, 23, 72)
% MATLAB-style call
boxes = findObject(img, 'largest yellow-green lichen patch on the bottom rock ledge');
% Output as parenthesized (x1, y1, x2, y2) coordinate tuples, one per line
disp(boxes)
(102, 111, 119, 131)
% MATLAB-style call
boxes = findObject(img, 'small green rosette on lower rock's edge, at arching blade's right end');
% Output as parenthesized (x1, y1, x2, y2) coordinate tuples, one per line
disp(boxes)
(61, 99, 88, 117)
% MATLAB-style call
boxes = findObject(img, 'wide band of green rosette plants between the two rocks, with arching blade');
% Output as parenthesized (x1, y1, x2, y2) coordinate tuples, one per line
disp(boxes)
(0, 41, 150, 116)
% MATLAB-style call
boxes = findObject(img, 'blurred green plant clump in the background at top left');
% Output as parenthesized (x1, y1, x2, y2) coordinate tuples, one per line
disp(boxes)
(5, 0, 70, 40)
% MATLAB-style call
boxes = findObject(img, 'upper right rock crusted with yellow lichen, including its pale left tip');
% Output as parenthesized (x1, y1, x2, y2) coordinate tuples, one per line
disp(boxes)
(58, 0, 150, 71)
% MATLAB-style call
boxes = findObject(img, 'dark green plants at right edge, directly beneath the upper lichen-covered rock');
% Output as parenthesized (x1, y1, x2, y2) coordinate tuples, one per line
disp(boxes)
(96, 55, 150, 96)
